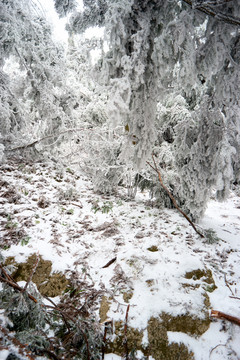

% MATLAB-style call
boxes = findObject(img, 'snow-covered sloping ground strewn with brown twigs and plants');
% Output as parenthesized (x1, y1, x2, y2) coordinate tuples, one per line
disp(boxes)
(0, 161, 240, 360)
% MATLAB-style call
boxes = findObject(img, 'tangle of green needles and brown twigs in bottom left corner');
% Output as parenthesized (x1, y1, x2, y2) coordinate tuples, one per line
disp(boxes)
(0, 258, 107, 360)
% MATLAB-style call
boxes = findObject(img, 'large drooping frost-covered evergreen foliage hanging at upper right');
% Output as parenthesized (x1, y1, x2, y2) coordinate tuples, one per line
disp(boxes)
(66, 0, 240, 218)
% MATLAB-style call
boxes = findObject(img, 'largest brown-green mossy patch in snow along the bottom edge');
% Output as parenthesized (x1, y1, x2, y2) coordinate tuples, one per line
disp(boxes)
(107, 312, 210, 360)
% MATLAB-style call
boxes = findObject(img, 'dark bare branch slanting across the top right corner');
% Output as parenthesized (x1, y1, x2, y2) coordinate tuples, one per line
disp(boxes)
(183, 0, 240, 26)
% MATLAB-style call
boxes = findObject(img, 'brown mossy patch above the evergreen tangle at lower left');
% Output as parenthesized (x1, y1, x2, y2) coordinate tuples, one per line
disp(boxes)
(5, 254, 68, 297)
